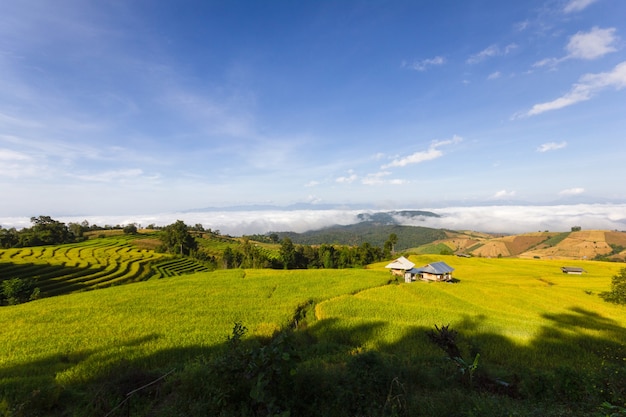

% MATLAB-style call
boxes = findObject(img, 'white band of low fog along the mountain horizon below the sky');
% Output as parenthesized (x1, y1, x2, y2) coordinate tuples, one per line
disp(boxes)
(0, 204, 626, 236)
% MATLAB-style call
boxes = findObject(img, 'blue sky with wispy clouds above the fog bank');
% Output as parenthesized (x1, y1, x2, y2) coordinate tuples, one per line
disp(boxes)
(0, 0, 626, 216)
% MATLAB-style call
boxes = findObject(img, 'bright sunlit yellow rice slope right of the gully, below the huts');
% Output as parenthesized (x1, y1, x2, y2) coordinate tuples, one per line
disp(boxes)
(317, 255, 626, 366)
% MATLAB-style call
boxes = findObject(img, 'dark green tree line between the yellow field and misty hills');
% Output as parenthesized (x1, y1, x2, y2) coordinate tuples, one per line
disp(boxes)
(0, 216, 398, 269)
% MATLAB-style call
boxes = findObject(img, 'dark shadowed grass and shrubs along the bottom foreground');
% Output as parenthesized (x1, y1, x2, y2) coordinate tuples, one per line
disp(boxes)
(0, 308, 626, 416)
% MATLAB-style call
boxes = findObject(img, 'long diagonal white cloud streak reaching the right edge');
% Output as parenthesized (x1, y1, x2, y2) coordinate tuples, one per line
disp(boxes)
(513, 61, 626, 119)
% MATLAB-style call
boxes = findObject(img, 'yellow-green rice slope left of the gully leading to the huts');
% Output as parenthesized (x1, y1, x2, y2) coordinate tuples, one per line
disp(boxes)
(0, 270, 388, 404)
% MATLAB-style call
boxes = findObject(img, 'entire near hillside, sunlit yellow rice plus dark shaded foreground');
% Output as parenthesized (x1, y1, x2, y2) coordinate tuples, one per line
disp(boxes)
(0, 255, 626, 417)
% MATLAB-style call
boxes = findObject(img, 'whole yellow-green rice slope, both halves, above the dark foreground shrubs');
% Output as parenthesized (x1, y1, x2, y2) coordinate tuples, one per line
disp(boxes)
(0, 255, 626, 414)
